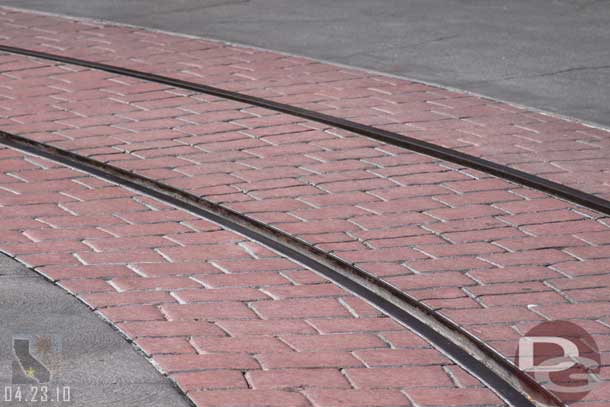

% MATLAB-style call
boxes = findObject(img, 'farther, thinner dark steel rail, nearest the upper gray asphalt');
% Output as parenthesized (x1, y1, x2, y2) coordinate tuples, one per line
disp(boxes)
(0, 44, 610, 215)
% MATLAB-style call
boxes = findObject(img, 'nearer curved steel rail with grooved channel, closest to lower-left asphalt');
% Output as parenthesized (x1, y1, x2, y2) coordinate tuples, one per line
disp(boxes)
(0, 131, 564, 406)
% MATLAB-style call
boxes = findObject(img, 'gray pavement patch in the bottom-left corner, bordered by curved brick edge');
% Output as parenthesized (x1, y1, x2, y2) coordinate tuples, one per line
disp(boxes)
(0, 254, 190, 407)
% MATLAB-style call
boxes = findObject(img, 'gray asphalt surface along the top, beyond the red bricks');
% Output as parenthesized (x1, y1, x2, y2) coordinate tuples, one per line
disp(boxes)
(0, 0, 610, 126)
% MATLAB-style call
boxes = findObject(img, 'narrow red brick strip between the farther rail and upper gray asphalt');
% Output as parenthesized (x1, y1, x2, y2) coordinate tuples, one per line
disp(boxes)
(0, 9, 610, 199)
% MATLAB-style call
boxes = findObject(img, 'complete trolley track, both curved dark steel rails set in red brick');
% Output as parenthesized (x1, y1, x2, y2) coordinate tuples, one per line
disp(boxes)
(0, 45, 592, 406)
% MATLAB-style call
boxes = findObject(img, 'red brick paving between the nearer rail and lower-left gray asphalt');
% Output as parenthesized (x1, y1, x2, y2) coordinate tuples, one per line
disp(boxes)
(0, 148, 504, 407)
